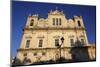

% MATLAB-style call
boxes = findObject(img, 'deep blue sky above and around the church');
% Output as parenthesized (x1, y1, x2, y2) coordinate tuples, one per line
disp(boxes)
(11, 1, 96, 56)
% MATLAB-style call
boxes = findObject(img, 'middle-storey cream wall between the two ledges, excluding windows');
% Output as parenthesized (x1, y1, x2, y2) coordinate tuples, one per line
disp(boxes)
(21, 30, 87, 48)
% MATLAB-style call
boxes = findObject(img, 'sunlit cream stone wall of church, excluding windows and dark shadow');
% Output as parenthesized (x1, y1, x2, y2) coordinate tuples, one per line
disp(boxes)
(17, 10, 94, 63)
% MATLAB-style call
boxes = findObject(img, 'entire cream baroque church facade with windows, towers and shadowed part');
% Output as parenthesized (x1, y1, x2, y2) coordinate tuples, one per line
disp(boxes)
(17, 10, 95, 63)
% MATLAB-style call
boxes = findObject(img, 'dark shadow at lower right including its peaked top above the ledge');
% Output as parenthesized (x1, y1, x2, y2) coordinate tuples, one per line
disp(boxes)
(70, 40, 90, 62)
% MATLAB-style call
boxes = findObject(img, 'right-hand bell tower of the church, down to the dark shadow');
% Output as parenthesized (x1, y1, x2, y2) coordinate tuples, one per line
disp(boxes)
(74, 16, 88, 46)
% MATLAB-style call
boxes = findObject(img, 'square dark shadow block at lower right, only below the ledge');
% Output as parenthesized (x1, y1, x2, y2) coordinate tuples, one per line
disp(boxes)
(71, 46, 90, 62)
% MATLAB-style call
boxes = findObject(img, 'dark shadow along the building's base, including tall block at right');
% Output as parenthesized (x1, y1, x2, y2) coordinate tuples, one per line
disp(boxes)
(12, 42, 95, 67)
